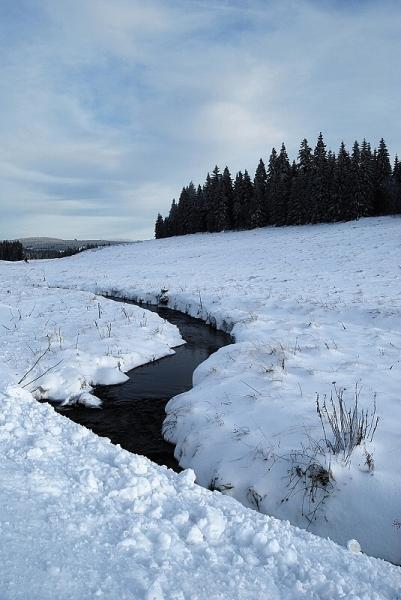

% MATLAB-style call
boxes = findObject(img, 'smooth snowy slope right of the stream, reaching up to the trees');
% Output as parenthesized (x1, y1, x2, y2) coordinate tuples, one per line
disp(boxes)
(13, 218, 401, 563)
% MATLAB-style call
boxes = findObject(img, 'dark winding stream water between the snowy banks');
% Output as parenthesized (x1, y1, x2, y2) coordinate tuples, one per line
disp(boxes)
(52, 299, 233, 470)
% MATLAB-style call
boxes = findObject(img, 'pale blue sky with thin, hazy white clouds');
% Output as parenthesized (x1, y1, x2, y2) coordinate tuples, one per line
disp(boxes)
(0, 0, 401, 239)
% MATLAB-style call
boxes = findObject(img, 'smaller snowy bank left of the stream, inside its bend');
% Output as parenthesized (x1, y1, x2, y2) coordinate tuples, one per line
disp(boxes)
(0, 278, 183, 406)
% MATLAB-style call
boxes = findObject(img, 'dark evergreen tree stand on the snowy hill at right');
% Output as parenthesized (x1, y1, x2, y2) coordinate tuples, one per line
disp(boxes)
(155, 133, 401, 238)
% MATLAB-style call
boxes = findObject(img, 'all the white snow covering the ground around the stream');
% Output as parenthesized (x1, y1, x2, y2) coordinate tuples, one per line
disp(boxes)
(0, 218, 401, 600)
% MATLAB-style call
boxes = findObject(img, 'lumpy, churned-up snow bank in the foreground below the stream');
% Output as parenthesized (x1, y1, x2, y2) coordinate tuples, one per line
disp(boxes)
(0, 387, 401, 600)
